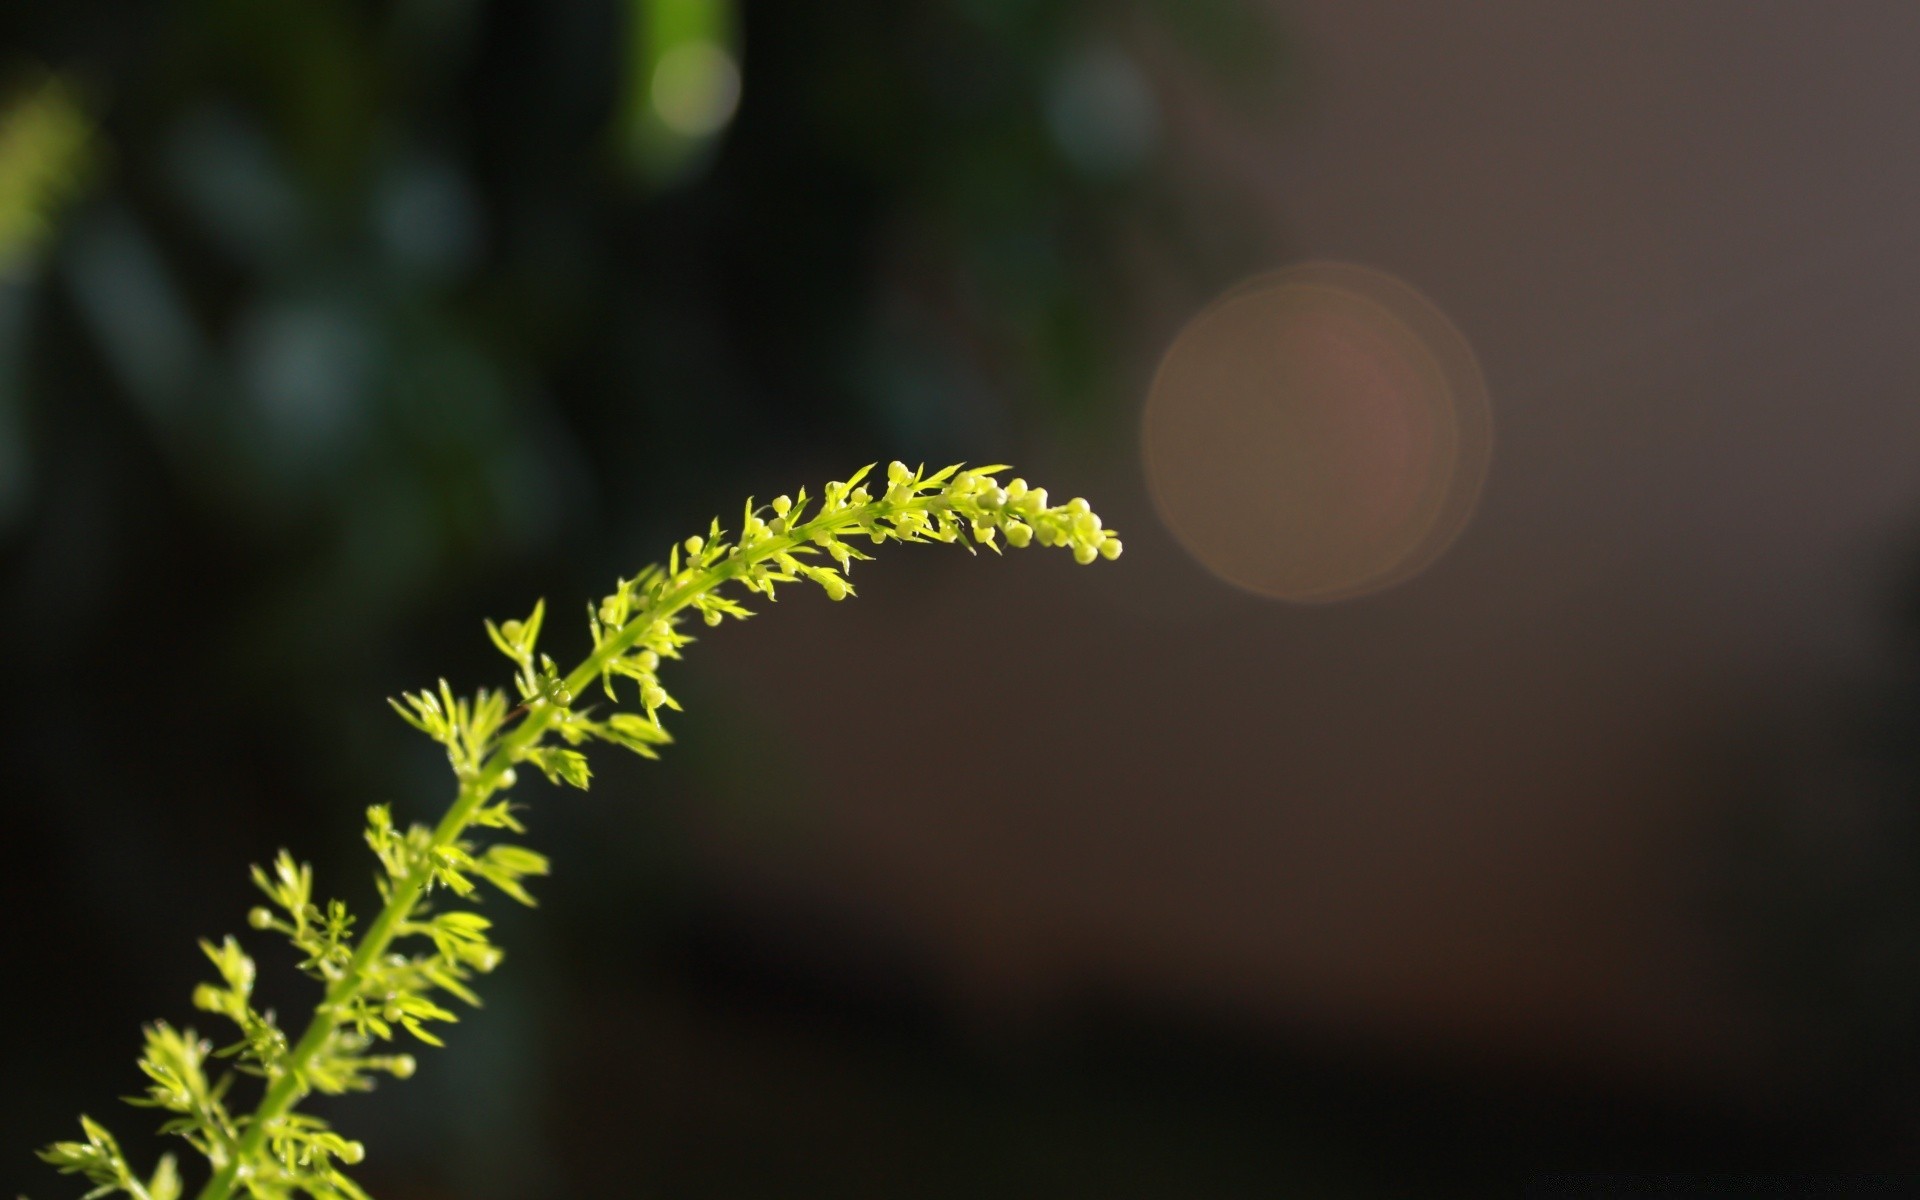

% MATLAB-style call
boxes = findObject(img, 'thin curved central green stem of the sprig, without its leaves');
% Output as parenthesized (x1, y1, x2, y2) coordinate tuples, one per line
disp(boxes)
(198, 495, 898, 1200)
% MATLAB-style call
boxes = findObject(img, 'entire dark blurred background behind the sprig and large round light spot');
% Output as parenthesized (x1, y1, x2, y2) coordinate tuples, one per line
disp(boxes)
(11, 0, 1920, 1200)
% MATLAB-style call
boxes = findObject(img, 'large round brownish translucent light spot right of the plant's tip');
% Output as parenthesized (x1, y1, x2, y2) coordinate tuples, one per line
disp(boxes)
(1140, 263, 1492, 601)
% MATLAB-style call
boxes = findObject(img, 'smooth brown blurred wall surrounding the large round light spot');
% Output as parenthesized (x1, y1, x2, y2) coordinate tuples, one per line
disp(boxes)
(695, 4, 1920, 1087)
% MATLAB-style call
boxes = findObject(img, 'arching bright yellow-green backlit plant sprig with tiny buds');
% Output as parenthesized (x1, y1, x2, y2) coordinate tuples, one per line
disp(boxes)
(40, 463, 1121, 1200)
